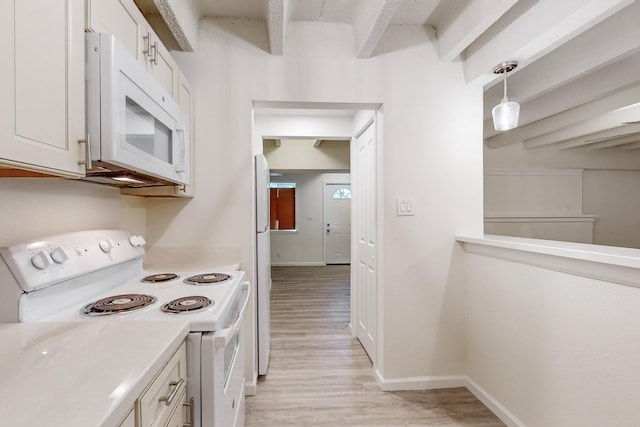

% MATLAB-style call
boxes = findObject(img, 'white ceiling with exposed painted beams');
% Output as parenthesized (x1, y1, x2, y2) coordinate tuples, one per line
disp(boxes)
(181, 0, 640, 154)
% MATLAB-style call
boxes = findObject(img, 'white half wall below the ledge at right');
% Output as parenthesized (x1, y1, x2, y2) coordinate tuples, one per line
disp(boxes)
(465, 253, 640, 427)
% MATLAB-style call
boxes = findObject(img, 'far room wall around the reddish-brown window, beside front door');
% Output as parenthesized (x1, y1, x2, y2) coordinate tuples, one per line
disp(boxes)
(271, 173, 351, 265)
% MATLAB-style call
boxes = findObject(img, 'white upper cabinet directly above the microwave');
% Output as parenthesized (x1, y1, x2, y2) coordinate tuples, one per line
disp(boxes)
(86, 0, 179, 99)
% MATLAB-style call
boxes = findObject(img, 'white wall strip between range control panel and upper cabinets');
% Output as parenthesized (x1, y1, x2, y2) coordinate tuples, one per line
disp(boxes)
(0, 178, 146, 246)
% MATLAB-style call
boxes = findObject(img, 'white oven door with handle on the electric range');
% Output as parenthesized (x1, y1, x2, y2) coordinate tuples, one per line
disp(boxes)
(196, 282, 250, 427)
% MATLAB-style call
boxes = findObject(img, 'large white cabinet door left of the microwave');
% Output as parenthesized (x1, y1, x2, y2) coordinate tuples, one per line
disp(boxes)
(0, 0, 85, 177)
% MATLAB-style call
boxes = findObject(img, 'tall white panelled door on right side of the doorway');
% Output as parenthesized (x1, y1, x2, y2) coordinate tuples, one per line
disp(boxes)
(352, 116, 378, 365)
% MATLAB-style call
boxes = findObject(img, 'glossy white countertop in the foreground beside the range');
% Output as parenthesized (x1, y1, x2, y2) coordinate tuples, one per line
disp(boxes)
(0, 321, 189, 427)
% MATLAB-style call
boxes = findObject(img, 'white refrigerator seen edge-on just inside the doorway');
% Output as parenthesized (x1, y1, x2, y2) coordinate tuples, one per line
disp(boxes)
(256, 154, 271, 375)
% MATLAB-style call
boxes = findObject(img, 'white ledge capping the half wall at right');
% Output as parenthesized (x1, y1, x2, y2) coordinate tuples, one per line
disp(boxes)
(456, 234, 640, 287)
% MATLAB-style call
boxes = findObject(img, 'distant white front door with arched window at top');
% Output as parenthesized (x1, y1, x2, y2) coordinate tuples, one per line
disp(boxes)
(324, 184, 351, 264)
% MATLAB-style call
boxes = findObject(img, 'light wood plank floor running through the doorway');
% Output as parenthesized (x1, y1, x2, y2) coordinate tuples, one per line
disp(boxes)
(246, 265, 504, 427)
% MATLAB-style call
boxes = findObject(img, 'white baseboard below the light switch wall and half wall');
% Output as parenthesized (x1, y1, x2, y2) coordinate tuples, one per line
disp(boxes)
(374, 369, 526, 427)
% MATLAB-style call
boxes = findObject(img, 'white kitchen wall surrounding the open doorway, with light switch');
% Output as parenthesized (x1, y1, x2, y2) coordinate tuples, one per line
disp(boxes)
(148, 19, 482, 379)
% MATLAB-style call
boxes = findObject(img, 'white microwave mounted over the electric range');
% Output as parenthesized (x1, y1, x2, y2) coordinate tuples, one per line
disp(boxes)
(85, 33, 190, 187)
